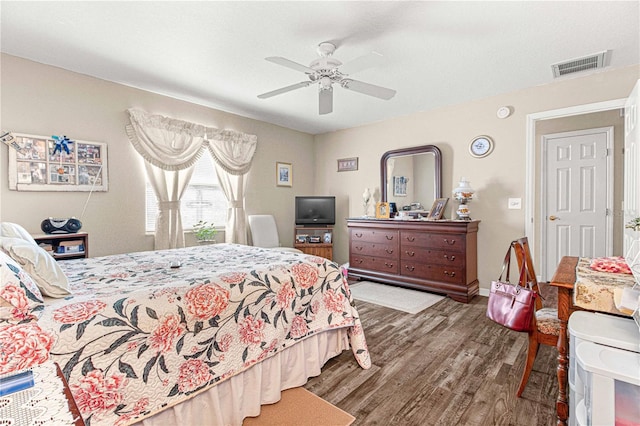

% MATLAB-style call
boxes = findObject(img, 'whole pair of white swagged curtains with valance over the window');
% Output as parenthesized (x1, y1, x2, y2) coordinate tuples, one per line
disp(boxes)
(126, 109, 257, 250)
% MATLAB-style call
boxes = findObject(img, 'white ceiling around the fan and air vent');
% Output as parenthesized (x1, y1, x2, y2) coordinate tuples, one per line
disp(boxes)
(0, 1, 640, 134)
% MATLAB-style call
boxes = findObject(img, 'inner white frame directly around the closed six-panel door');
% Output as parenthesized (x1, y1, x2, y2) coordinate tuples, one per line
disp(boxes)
(538, 126, 614, 281)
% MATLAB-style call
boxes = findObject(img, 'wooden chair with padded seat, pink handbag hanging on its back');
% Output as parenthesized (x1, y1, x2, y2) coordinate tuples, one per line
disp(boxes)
(511, 237, 560, 398)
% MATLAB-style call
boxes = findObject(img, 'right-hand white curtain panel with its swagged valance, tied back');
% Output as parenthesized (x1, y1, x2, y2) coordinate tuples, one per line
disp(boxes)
(206, 129, 257, 244)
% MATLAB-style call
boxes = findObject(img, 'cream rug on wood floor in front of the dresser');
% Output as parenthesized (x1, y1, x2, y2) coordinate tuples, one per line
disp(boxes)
(349, 281, 444, 314)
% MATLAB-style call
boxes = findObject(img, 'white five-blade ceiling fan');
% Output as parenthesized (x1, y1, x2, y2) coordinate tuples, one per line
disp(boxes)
(258, 42, 396, 114)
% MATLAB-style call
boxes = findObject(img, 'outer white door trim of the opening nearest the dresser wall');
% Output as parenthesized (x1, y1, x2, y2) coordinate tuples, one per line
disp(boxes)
(524, 98, 627, 282)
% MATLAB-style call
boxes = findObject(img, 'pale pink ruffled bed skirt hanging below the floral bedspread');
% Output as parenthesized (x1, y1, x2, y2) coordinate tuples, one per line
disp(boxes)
(135, 328, 350, 426)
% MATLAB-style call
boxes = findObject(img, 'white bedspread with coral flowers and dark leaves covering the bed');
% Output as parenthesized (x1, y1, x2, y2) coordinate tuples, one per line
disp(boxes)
(38, 244, 371, 426)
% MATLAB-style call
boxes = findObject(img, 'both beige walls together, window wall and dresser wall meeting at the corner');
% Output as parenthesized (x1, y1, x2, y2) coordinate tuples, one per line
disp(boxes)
(0, 55, 640, 289)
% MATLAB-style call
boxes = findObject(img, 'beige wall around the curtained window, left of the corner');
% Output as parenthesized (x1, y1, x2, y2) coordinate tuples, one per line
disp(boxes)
(0, 54, 314, 256)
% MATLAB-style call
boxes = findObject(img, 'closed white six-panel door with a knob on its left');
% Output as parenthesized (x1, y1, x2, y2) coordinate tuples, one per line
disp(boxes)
(542, 127, 613, 278)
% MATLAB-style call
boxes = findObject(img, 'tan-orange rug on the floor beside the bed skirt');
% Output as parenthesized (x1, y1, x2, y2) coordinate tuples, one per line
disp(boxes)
(242, 388, 355, 426)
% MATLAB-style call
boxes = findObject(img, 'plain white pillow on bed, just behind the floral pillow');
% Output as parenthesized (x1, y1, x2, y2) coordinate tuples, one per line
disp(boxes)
(0, 237, 71, 298)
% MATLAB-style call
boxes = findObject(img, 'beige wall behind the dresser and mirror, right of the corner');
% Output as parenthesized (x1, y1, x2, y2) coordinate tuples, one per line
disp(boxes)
(315, 66, 640, 289)
